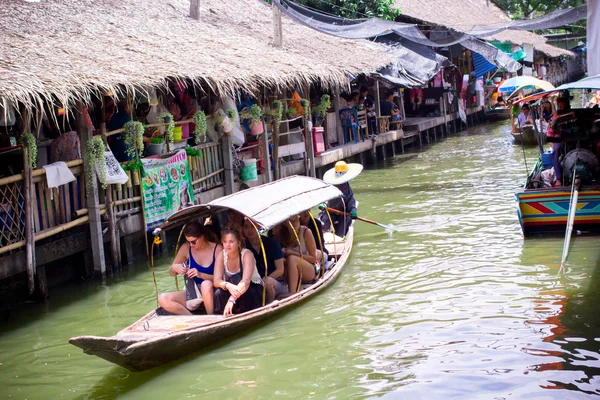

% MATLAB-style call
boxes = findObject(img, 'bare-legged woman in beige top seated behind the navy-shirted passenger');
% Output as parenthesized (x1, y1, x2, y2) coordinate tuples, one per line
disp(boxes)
(281, 215, 322, 294)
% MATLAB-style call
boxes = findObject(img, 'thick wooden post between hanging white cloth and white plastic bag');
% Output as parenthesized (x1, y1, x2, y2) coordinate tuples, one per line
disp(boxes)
(75, 102, 106, 279)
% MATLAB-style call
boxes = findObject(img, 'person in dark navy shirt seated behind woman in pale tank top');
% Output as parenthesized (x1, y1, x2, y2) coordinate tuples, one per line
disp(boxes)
(243, 220, 287, 303)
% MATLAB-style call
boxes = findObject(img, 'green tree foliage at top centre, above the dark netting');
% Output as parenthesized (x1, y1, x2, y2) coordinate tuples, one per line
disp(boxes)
(295, 0, 400, 20)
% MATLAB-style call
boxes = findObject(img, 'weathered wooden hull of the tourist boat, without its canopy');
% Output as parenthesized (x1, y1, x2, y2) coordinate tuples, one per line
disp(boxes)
(69, 226, 354, 371)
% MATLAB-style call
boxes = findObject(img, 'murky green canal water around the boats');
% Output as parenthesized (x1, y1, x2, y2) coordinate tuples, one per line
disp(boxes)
(0, 124, 600, 399)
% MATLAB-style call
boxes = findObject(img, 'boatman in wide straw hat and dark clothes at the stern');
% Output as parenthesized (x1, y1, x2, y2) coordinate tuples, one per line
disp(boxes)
(319, 161, 363, 237)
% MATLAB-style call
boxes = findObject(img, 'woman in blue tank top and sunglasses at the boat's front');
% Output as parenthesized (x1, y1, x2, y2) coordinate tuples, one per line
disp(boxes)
(158, 222, 222, 315)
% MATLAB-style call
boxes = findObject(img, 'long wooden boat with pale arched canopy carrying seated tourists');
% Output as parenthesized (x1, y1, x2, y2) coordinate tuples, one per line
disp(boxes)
(69, 176, 354, 371)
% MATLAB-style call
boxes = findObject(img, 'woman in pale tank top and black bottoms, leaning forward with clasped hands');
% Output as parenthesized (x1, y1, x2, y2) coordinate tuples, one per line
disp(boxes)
(214, 229, 263, 317)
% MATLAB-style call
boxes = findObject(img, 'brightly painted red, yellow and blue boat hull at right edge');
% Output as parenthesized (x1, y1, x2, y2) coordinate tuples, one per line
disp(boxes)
(516, 187, 600, 236)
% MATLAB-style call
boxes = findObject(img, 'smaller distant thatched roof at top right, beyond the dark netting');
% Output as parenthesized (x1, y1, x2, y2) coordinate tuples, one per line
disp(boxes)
(395, 0, 573, 57)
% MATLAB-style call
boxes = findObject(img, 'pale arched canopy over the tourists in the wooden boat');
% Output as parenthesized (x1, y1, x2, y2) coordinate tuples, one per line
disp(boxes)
(160, 176, 342, 230)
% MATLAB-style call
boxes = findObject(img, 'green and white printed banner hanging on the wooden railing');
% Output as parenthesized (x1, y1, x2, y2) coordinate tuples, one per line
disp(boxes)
(142, 150, 194, 230)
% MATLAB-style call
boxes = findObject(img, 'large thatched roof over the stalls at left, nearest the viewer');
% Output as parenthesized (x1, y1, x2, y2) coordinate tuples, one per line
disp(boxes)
(0, 0, 393, 110)
